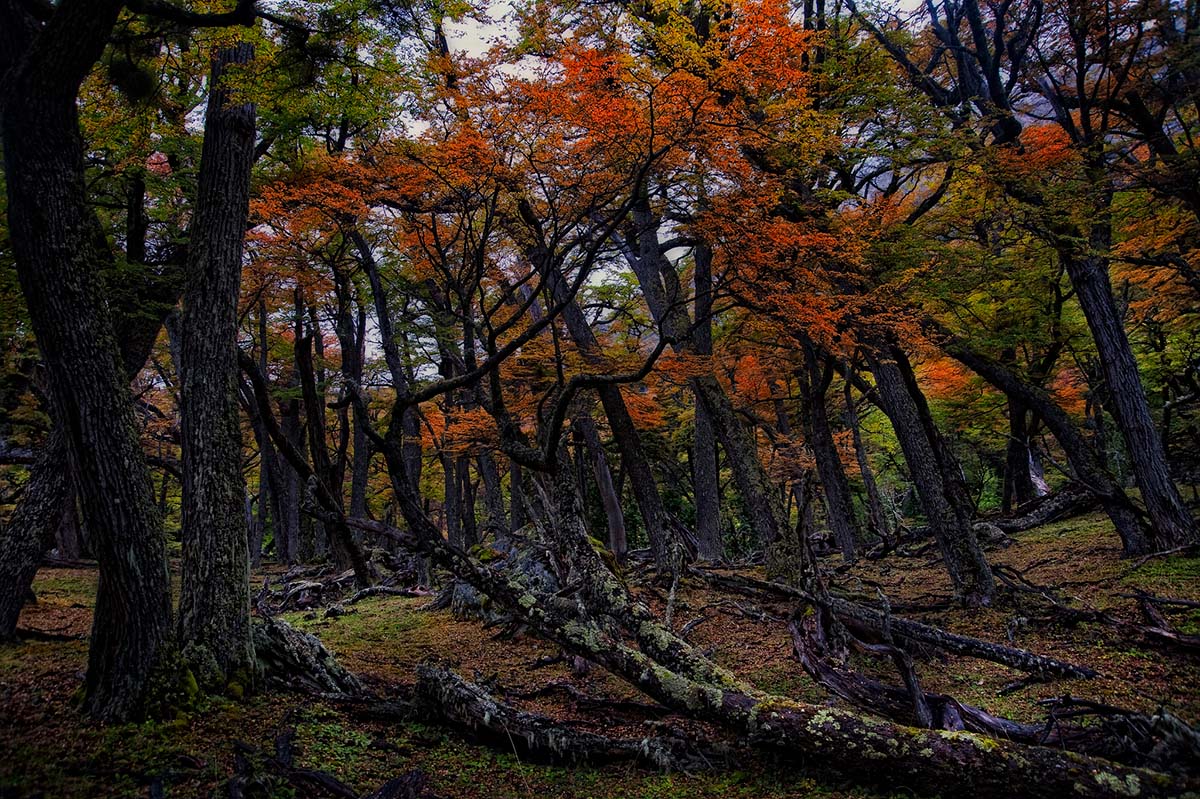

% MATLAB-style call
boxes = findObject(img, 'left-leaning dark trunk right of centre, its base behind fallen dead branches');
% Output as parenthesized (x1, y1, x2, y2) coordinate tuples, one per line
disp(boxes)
(871, 358, 995, 605)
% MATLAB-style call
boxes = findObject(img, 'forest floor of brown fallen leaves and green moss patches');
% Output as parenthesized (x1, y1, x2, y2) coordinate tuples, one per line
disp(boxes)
(0, 506, 1200, 799)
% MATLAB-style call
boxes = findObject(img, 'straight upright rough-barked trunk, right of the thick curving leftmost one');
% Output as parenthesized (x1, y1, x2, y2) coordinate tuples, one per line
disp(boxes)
(178, 44, 256, 690)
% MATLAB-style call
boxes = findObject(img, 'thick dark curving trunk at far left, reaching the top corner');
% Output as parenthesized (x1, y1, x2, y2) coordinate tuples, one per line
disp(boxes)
(0, 0, 170, 721)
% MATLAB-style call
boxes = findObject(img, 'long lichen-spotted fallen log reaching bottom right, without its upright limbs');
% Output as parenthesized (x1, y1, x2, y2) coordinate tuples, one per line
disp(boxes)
(376, 517, 1200, 799)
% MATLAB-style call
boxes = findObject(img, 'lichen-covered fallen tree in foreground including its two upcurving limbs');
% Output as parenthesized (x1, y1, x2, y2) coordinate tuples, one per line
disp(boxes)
(372, 431, 1200, 799)
